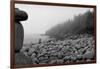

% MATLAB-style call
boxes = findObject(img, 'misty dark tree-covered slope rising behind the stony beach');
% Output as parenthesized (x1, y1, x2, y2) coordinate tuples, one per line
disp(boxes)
(46, 10, 94, 39)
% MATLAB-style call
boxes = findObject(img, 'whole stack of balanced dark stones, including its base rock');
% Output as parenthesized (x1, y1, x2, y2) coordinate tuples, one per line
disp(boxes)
(15, 8, 32, 65)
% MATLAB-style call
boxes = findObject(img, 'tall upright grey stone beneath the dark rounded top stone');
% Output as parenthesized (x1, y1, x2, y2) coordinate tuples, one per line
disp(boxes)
(15, 22, 24, 51)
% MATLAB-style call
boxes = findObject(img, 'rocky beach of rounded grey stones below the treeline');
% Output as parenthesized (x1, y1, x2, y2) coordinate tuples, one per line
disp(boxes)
(21, 34, 95, 64)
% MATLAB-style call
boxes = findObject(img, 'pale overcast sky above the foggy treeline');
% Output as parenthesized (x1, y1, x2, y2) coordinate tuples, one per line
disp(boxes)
(15, 4, 93, 35)
